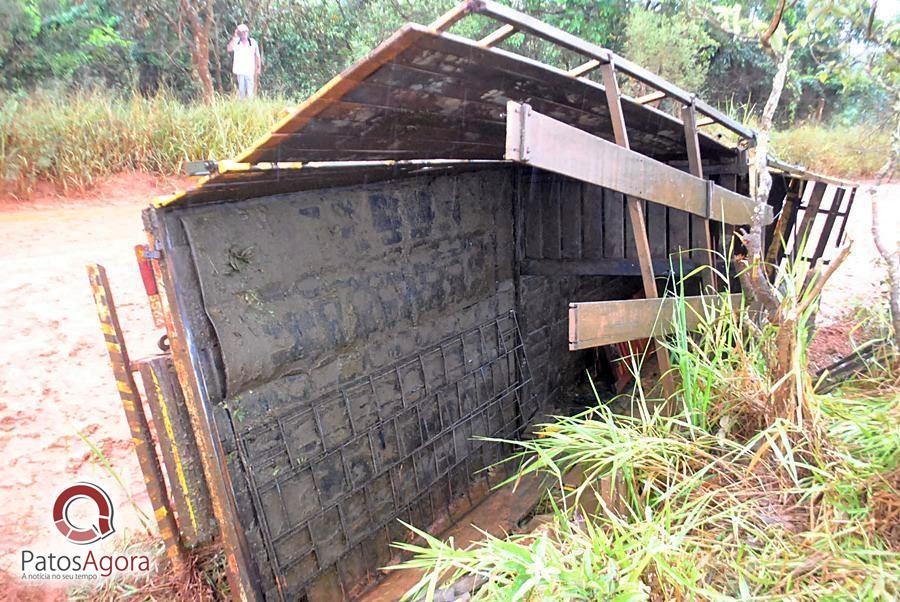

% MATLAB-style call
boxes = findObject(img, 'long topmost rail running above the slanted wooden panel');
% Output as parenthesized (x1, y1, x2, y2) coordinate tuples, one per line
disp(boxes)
(460, 0, 756, 140)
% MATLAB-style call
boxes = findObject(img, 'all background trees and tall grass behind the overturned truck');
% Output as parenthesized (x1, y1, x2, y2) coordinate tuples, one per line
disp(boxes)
(0, 0, 898, 194)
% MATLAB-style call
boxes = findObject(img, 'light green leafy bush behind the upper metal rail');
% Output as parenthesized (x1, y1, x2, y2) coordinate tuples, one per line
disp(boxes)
(624, 8, 718, 91)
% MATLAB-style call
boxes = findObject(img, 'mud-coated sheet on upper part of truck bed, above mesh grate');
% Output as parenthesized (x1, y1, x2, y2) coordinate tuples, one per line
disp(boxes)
(183, 166, 512, 395)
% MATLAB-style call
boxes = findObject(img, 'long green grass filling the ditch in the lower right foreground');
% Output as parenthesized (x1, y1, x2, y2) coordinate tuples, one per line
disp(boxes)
(395, 264, 900, 600)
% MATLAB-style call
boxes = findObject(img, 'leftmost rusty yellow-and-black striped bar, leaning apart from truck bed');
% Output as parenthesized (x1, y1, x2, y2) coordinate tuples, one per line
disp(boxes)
(87, 263, 186, 572)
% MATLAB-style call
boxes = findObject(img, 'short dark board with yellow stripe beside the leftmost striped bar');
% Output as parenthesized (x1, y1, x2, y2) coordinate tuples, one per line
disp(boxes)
(135, 355, 218, 547)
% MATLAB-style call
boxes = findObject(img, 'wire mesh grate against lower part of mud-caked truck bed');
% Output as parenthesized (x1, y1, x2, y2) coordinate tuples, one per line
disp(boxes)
(234, 311, 536, 598)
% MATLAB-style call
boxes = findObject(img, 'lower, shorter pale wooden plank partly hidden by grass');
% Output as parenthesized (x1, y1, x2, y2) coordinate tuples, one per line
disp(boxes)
(569, 293, 741, 351)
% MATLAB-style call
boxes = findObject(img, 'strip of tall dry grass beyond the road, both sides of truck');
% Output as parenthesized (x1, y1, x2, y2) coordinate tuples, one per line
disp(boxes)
(0, 90, 890, 194)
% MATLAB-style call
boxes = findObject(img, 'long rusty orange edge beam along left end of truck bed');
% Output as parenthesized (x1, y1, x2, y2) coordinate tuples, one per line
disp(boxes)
(145, 210, 263, 600)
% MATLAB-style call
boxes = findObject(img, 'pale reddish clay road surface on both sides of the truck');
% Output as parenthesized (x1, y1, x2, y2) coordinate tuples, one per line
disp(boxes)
(0, 174, 900, 600)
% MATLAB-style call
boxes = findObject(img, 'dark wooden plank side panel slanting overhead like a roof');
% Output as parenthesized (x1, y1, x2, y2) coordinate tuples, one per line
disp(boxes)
(242, 26, 734, 168)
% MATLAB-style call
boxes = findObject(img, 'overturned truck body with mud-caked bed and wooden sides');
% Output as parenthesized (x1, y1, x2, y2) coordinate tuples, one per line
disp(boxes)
(121, 2, 855, 600)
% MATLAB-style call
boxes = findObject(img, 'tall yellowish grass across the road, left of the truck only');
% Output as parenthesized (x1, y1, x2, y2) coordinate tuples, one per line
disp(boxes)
(0, 90, 288, 191)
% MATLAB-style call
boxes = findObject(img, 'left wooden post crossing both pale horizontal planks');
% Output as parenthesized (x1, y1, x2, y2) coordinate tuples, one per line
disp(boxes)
(600, 62, 675, 398)
